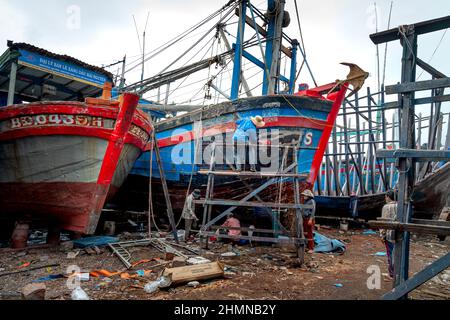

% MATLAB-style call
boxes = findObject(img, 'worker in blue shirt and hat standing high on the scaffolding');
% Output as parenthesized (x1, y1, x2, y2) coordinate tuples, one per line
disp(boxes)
(233, 116, 266, 172)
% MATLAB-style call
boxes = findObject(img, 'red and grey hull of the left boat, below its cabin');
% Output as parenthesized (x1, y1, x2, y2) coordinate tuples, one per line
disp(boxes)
(0, 94, 151, 234)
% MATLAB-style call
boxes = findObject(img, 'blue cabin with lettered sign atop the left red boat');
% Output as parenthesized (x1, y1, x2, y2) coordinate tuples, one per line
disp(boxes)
(0, 41, 114, 107)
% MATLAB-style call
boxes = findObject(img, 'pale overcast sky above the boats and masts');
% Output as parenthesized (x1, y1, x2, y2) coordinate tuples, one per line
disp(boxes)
(0, 0, 450, 142)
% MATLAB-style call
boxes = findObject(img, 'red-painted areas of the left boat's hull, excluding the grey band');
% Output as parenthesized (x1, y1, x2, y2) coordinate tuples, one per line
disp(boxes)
(0, 93, 151, 234)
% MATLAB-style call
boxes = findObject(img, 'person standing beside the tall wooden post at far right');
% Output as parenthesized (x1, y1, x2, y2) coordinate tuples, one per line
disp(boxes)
(380, 190, 397, 278)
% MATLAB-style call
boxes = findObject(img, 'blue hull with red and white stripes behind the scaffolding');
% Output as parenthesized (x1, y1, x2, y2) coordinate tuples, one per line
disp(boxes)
(130, 77, 366, 213)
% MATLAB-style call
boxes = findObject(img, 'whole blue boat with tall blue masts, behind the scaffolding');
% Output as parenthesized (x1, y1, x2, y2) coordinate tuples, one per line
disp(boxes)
(118, 1, 368, 220)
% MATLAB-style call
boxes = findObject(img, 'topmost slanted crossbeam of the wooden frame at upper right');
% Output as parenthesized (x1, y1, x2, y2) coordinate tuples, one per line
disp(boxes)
(370, 16, 450, 44)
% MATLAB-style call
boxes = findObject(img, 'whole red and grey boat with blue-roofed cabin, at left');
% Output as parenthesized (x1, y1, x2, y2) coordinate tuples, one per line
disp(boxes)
(0, 44, 150, 234)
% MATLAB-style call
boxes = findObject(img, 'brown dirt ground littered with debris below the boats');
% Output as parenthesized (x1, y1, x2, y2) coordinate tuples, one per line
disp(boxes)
(0, 229, 450, 300)
